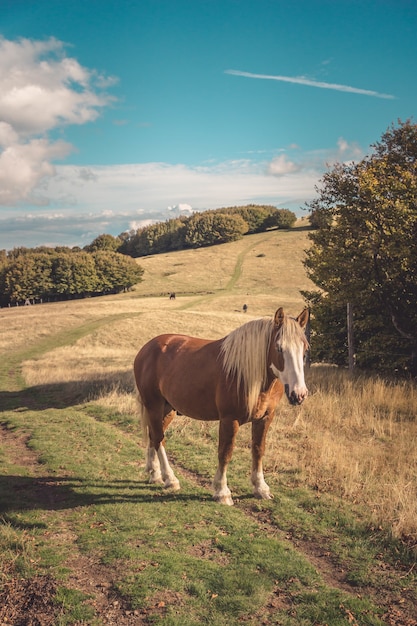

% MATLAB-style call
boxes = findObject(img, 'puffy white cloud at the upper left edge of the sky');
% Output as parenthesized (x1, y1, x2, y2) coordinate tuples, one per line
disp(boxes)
(0, 38, 113, 206)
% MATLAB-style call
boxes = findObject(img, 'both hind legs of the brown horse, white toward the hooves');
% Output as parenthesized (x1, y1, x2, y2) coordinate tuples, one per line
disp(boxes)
(146, 402, 180, 490)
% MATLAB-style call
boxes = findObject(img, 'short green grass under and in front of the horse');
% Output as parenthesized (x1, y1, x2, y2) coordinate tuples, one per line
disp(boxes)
(1, 398, 398, 626)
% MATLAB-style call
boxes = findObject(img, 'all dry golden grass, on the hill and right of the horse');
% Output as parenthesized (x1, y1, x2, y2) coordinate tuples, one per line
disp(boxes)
(4, 231, 417, 542)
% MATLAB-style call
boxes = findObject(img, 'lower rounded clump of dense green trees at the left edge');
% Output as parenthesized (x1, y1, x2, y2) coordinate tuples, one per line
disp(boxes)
(0, 247, 143, 306)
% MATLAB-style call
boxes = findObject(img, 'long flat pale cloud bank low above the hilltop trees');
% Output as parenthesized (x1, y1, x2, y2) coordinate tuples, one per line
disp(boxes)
(0, 138, 363, 249)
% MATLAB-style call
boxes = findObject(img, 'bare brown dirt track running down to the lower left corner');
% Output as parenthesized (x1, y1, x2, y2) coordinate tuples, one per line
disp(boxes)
(0, 424, 148, 626)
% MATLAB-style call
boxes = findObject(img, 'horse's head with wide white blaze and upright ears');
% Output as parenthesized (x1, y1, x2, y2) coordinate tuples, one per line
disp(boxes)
(270, 307, 309, 404)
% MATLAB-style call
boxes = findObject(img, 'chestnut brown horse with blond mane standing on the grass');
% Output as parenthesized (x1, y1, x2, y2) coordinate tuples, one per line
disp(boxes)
(134, 307, 309, 505)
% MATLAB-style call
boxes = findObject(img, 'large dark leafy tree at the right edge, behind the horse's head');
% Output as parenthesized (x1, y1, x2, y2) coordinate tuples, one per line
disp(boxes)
(305, 121, 417, 374)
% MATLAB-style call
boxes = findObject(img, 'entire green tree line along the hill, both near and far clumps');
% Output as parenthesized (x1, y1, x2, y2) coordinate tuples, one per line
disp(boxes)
(0, 205, 296, 306)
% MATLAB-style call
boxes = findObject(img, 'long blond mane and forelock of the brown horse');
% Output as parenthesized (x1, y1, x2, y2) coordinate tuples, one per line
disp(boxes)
(221, 316, 307, 415)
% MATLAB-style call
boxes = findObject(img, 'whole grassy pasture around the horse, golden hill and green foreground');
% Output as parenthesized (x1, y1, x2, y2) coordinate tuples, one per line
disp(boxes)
(0, 228, 417, 626)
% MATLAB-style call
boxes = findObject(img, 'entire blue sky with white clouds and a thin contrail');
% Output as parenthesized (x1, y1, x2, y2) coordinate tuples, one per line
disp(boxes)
(0, 0, 417, 250)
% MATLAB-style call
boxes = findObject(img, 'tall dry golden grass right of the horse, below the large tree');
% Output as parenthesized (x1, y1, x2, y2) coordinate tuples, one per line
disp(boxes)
(268, 366, 417, 543)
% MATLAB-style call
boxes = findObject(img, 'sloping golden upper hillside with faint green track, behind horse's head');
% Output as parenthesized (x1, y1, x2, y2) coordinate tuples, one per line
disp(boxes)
(135, 221, 314, 316)
